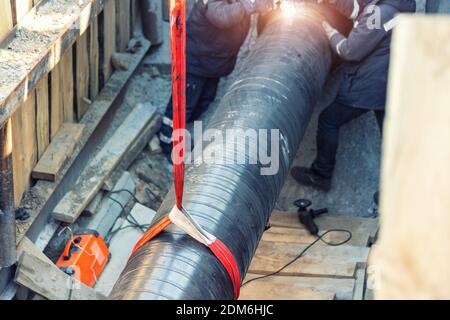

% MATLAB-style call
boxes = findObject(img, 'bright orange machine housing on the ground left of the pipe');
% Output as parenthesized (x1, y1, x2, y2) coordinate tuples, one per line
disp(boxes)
(56, 230, 110, 287)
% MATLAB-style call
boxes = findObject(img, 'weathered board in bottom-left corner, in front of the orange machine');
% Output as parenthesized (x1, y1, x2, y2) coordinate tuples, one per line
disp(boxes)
(15, 252, 106, 300)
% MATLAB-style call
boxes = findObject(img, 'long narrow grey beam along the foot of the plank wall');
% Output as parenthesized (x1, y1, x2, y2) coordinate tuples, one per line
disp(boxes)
(16, 39, 150, 242)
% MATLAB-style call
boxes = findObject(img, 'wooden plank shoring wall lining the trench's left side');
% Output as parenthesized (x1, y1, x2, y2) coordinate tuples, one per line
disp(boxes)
(0, 0, 138, 207)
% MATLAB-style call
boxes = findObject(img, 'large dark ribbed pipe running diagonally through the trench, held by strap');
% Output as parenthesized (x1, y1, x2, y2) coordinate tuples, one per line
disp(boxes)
(110, 5, 348, 299)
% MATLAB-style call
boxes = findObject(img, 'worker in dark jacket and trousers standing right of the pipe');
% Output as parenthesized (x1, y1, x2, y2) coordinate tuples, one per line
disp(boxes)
(291, 0, 416, 191)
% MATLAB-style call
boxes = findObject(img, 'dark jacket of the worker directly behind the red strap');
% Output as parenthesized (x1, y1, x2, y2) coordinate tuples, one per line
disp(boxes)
(186, 0, 250, 78)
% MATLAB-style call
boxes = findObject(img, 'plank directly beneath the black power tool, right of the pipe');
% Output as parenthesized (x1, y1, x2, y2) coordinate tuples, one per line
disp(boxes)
(270, 211, 378, 244)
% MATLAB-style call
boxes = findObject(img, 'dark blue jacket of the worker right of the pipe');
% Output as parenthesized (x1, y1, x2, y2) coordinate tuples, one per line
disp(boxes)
(331, 0, 416, 110)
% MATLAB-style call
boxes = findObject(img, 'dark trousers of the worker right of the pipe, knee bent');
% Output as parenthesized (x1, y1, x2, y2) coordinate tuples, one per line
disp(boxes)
(311, 102, 384, 178)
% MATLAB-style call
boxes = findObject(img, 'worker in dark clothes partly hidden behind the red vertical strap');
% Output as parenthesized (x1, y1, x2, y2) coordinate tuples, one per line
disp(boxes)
(159, 0, 273, 159)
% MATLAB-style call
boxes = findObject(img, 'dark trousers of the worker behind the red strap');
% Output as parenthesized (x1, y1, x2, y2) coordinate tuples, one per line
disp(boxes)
(159, 73, 219, 155)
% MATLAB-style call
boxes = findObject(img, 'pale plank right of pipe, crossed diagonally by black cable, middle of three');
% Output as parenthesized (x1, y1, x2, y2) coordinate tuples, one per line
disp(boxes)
(249, 241, 369, 278)
